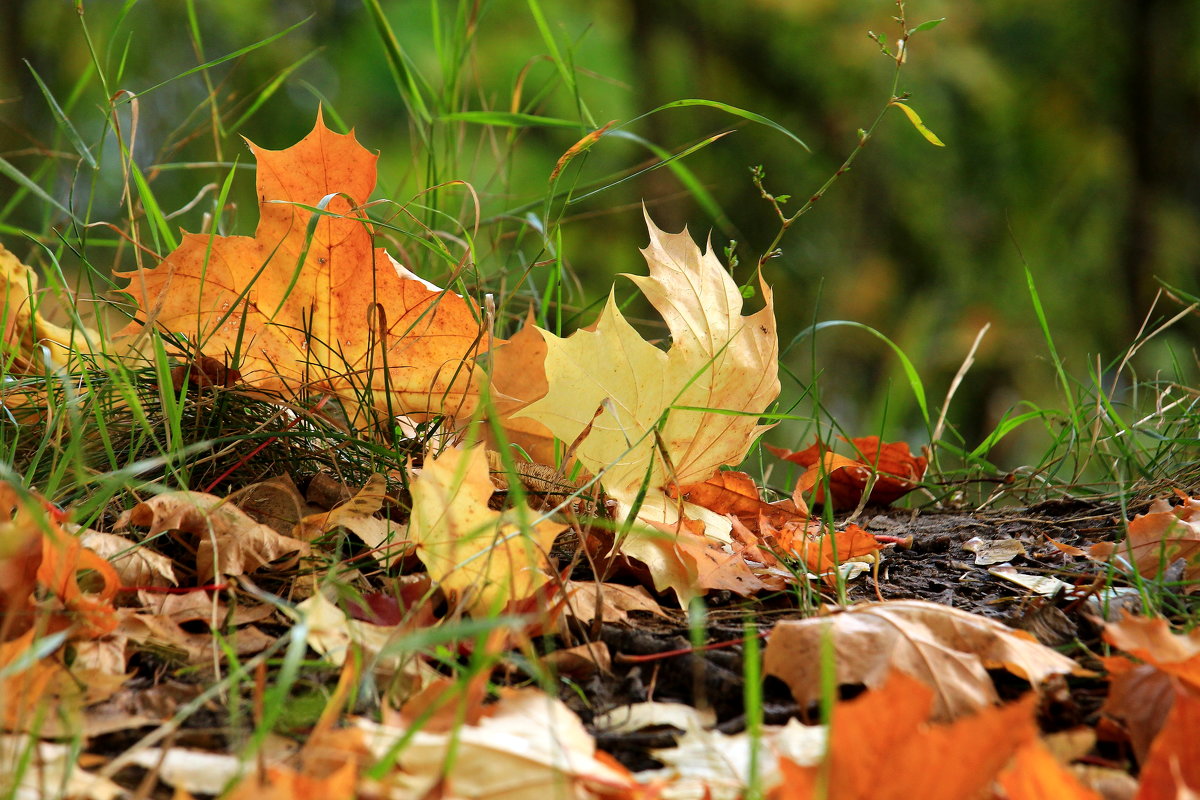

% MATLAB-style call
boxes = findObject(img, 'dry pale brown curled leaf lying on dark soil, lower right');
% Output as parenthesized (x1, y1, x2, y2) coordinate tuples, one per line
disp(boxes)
(763, 600, 1079, 722)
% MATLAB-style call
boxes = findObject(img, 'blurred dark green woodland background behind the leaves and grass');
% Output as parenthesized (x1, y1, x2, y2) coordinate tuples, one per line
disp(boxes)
(0, 0, 1200, 468)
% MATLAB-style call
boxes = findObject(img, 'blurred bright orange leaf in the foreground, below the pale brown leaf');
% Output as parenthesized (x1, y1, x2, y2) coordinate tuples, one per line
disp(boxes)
(772, 673, 1037, 800)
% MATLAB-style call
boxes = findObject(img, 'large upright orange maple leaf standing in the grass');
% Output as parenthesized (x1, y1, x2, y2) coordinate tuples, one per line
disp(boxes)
(119, 112, 480, 424)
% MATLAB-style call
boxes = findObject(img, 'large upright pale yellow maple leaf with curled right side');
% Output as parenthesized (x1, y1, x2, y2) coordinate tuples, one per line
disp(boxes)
(514, 215, 780, 536)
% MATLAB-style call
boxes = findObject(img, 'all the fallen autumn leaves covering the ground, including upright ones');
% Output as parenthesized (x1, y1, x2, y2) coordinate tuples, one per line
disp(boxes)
(0, 110, 1200, 800)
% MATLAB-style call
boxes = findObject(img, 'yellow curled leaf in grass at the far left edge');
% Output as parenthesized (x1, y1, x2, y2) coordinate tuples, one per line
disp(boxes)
(0, 245, 100, 373)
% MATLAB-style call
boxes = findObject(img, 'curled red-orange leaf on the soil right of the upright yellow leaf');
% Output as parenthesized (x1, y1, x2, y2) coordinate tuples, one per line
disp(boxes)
(767, 437, 928, 511)
